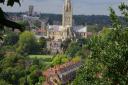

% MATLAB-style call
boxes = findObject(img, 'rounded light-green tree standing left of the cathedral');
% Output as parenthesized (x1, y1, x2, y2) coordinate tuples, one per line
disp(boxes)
(17, 31, 40, 54)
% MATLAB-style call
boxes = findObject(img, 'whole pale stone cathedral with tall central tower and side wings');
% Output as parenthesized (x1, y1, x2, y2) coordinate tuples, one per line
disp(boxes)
(47, 0, 87, 53)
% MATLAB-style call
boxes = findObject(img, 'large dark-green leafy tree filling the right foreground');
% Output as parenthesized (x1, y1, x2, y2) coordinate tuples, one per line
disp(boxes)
(73, 4, 128, 85)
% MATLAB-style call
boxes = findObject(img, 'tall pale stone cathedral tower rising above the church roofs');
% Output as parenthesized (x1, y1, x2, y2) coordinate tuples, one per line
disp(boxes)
(62, 0, 72, 27)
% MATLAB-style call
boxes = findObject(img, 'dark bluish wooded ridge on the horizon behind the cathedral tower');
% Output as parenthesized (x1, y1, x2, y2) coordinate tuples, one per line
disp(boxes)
(40, 14, 111, 26)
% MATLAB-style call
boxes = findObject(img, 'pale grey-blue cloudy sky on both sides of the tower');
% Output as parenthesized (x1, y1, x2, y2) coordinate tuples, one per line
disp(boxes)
(0, 0, 128, 15)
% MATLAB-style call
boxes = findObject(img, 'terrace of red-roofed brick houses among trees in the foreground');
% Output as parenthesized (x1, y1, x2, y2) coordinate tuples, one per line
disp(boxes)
(43, 61, 81, 85)
